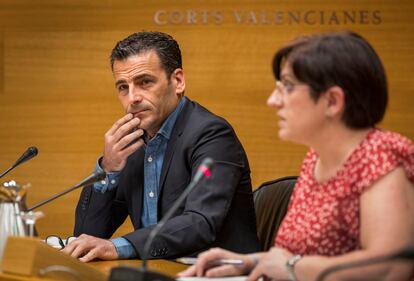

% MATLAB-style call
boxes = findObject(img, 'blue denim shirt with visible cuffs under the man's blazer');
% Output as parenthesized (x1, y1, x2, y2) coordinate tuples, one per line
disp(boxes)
(93, 97, 187, 258)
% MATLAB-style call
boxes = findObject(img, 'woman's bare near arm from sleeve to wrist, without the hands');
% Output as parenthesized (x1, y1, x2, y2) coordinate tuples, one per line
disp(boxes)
(295, 167, 414, 281)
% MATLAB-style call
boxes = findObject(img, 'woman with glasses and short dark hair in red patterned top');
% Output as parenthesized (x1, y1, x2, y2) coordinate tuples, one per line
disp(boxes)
(179, 32, 414, 281)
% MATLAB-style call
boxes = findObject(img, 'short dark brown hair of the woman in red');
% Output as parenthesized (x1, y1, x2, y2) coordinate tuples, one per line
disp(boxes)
(273, 32, 388, 129)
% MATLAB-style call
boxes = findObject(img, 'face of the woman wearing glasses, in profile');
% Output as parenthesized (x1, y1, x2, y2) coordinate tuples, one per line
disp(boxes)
(267, 62, 325, 145)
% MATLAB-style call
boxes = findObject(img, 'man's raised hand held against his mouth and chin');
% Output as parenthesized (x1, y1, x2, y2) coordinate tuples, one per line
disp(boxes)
(101, 113, 144, 172)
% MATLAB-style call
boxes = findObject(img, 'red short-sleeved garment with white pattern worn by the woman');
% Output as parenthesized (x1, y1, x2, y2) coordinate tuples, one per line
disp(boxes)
(275, 129, 414, 256)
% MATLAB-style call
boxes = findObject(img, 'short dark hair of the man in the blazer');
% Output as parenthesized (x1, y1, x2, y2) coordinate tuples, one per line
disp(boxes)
(110, 31, 182, 78)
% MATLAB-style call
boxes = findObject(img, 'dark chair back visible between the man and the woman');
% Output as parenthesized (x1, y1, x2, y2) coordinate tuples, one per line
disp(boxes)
(253, 176, 298, 251)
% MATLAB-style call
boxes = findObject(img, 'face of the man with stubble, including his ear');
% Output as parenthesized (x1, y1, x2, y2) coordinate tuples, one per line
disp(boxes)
(113, 50, 185, 136)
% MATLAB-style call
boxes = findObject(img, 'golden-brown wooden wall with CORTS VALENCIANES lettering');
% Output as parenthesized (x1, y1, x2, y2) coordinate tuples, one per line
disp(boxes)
(0, 0, 414, 236)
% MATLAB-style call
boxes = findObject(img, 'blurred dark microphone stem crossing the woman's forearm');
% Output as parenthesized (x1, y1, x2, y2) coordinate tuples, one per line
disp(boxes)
(316, 245, 414, 281)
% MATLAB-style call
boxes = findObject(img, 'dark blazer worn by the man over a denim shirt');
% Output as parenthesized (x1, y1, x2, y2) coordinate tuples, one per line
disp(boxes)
(74, 99, 260, 258)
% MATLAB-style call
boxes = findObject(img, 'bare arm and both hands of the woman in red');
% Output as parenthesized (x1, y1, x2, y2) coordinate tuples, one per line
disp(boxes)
(180, 168, 414, 281)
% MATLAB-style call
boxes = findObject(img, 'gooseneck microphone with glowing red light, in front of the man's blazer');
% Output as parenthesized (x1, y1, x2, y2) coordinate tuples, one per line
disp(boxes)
(109, 157, 214, 281)
